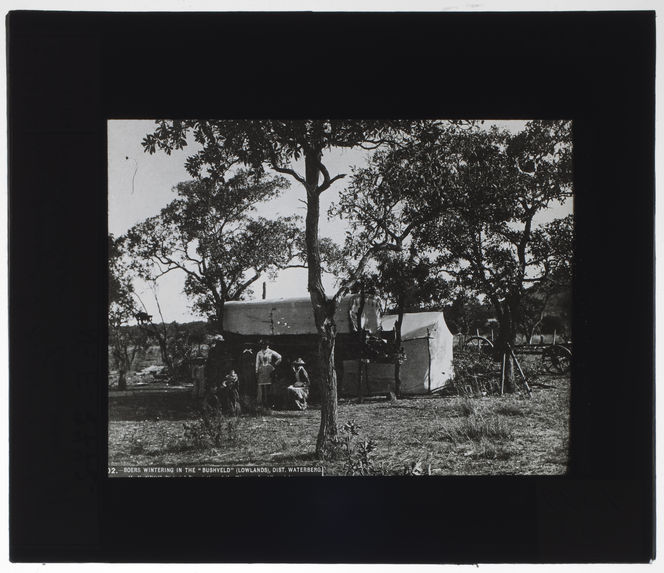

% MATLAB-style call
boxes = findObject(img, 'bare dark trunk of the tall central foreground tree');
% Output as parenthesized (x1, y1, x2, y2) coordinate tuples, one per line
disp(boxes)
(305, 150, 337, 459)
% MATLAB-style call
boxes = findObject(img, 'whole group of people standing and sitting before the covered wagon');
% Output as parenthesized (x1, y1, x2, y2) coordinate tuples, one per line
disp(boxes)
(204, 340, 310, 414)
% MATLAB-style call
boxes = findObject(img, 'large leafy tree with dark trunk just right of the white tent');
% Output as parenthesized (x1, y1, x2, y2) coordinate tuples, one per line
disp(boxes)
(406, 121, 573, 391)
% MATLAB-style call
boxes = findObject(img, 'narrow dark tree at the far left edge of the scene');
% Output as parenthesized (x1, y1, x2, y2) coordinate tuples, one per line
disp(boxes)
(108, 234, 146, 390)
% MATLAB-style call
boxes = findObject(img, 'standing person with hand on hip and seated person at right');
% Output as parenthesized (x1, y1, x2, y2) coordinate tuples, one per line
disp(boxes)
(256, 340, 310, 410)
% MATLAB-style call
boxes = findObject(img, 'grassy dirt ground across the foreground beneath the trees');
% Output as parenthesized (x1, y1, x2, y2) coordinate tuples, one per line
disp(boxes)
(109, 368, 570, 475)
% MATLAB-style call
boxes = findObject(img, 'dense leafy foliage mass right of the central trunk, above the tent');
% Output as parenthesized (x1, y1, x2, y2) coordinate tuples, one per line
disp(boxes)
(336, 121, 572, 392)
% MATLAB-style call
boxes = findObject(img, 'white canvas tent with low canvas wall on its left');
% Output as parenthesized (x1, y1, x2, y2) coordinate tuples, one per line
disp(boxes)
(343, 312, 453, 395)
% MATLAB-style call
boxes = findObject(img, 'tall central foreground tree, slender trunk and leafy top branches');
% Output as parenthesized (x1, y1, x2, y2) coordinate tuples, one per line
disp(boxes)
(143, 120, 420, 457)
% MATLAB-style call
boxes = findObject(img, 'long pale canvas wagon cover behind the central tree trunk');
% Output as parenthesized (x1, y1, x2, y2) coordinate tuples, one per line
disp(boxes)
(224, 296, 380, 336)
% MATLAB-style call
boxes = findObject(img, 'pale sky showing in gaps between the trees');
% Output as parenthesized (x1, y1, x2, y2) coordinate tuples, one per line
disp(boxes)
(108, 120, 572, 322)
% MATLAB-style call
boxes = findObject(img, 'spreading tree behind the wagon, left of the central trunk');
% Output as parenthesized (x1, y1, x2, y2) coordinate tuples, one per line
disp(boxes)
(127, 170, 304, 330)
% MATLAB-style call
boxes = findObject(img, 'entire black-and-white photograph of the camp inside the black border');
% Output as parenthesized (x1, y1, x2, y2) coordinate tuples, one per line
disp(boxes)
(107, 118, 574, 477)
